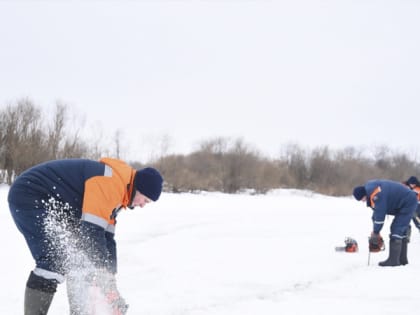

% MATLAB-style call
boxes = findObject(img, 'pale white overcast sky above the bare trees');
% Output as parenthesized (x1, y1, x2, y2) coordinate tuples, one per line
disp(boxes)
(0, 0, 420, 163)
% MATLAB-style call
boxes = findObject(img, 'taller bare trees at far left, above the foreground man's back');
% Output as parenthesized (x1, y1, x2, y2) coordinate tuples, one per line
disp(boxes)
(0, 99, 105, 184)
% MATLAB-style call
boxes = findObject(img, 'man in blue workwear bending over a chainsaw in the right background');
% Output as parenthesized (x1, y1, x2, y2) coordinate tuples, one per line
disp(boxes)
(353, 179, 417, 266)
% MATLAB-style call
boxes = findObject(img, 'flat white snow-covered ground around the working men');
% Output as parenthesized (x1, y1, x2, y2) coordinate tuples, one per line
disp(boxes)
(0, 185, 420, 315)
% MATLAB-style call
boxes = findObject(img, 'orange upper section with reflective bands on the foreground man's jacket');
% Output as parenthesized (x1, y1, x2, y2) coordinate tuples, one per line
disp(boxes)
(82, 158, 136, 232)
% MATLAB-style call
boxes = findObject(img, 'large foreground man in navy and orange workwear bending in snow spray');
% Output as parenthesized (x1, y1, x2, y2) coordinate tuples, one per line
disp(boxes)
(8, 158, 163, 315)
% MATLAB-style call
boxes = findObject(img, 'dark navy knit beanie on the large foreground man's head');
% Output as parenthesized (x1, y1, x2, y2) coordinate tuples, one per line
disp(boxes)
(134, 167, 163, 201)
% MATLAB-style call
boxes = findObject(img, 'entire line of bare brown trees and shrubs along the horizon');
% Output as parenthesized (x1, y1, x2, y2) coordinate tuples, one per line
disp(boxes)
(0, 99, 420, 196)
